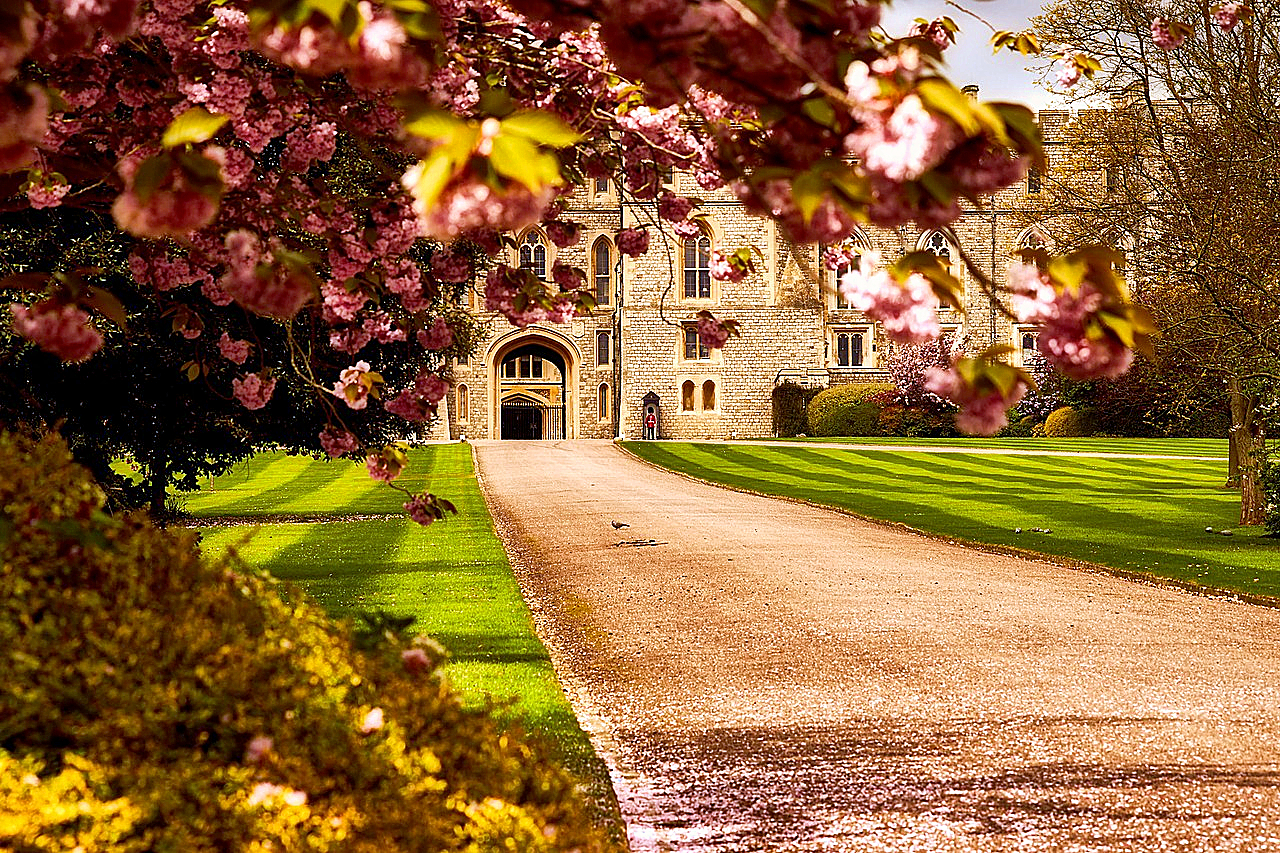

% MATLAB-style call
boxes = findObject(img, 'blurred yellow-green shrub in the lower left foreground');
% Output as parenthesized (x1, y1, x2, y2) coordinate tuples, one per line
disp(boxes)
(0, 435, 600, 853)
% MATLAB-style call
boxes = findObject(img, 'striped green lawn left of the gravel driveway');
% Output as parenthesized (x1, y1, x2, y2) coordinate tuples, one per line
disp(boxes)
(186, 444, 621, 831)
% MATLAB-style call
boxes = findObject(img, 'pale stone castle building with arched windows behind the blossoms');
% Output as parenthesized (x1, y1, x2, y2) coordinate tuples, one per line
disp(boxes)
(447, 111, 1069, 439)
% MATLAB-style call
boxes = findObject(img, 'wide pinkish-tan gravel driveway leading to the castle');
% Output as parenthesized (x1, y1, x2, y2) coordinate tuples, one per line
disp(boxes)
(476, 442, 1280, 853)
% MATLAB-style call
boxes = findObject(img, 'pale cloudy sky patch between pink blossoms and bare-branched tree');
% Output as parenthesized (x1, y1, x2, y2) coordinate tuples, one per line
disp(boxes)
(881, 0, 1059, 109)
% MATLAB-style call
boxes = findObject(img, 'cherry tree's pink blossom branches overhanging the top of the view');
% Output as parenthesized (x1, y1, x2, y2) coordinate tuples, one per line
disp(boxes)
(0, 0, 1208, 500)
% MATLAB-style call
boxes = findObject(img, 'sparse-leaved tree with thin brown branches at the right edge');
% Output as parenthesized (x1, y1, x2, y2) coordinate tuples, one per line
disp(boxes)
(1034, 0, 1280, 524)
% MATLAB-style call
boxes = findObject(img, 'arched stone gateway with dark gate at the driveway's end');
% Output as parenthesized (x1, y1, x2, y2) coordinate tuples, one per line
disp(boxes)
(489, 332, 579, 441)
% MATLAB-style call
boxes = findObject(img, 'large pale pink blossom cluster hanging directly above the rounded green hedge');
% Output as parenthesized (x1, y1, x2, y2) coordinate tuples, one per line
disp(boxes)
(838, 251, 942, 343)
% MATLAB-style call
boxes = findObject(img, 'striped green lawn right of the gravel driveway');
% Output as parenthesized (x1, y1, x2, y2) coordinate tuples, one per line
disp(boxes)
(625, 439, 1280, 603)
